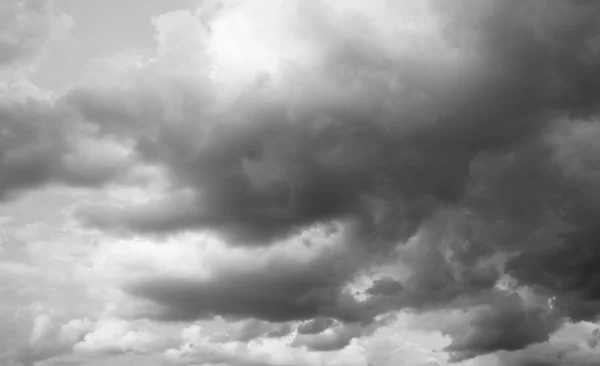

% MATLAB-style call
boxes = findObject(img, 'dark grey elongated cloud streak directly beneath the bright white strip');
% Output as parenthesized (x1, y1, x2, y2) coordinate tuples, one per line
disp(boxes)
(120, 232, 377, 322)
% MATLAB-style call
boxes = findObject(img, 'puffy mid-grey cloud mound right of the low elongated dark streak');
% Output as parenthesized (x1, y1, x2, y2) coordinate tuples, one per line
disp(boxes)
(366, 207, 503, 318)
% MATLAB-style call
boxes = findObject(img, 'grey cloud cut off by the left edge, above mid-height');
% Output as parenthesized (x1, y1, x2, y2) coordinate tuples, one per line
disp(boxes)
(0, 97, 130, 201)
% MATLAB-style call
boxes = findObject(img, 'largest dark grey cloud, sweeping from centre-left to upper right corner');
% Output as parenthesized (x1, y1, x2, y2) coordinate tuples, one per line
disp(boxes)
(68, 1, 598, 249)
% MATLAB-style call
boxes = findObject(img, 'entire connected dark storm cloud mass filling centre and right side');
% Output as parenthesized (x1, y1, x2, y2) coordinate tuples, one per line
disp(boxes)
(27, 0, 600, 359)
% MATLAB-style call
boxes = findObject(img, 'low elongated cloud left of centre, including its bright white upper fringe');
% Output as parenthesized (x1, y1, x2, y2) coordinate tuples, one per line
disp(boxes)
(118, 223, 376, 322)
